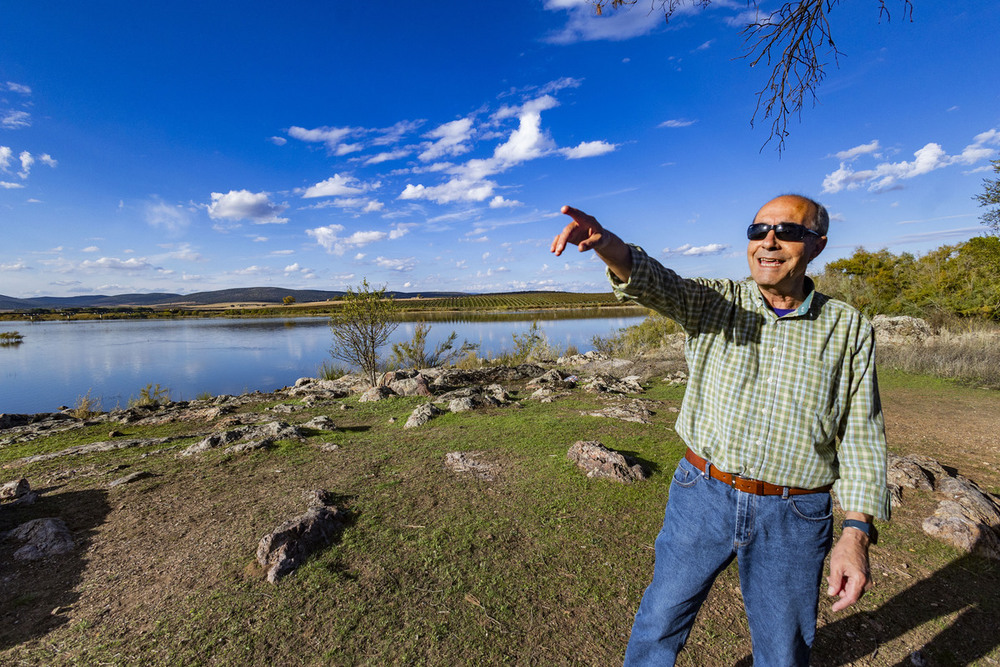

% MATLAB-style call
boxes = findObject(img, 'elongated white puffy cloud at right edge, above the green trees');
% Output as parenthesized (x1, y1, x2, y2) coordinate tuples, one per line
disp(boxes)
(823, 129, 1000, 193)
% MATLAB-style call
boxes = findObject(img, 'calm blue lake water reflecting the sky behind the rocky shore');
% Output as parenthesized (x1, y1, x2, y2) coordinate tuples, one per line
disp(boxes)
(0, 316, 642, 413)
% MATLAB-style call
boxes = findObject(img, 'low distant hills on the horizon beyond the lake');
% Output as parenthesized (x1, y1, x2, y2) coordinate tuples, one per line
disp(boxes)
(0, 287, 467, 310)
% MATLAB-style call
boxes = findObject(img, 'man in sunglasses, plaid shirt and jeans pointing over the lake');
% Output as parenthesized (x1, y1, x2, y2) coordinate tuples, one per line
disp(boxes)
(552, 195, 889, 667)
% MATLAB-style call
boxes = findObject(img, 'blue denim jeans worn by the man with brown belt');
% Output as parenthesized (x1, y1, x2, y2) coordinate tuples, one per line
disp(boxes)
(625, 459, 833, 667)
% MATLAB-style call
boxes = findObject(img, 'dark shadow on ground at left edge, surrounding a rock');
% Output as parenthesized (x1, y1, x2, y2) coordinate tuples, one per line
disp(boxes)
(0, 490, 111, 650)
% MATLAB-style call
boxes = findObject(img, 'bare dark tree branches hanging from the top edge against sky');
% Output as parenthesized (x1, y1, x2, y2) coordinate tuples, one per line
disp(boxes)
(591, 0, 913, 153)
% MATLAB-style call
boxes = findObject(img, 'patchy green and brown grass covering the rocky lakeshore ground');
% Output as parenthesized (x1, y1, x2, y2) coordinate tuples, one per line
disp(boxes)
(0, 373, 997, 665)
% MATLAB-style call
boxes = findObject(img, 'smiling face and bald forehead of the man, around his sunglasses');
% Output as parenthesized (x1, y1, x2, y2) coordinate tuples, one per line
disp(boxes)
(747, 196, 826, 296)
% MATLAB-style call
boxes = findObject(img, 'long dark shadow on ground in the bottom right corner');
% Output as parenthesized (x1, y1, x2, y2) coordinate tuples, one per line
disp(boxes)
(812, 536, 1000, 667)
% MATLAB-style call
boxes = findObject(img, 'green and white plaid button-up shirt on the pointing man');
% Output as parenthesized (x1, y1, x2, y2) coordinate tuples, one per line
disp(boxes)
(608, 246, 889, 519)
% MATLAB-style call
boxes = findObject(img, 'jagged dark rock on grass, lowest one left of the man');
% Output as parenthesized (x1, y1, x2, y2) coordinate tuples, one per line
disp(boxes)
(257, 490, 346, 583)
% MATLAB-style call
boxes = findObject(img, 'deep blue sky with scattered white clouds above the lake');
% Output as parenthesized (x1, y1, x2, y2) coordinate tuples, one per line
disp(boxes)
(0, 0, 1000, 297)
